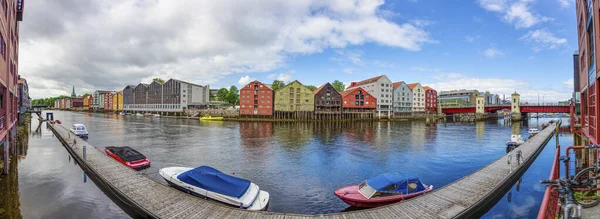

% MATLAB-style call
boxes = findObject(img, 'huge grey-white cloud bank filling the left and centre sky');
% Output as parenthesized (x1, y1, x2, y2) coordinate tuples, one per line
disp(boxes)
(19, 0, 435, 98)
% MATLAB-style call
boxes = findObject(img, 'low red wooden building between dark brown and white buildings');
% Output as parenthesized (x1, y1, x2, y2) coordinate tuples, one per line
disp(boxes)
(340, 87, 377, 112)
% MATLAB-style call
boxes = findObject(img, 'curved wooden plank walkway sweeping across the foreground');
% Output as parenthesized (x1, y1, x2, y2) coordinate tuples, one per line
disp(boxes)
(50, 124, 556, 219)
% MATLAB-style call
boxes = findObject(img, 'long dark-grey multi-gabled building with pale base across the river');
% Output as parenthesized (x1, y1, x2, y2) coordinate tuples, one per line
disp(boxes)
(123, 79, 210, 112)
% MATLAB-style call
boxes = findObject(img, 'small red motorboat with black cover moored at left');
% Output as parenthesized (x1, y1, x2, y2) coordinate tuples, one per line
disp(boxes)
(104, 146, 150, 170)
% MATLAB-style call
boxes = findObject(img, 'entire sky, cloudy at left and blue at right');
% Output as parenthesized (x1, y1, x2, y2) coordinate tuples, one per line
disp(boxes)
(19, 0, 578, 102)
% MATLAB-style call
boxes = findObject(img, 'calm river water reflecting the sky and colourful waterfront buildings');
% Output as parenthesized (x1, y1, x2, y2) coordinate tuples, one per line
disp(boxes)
(0, 111, 573, 218)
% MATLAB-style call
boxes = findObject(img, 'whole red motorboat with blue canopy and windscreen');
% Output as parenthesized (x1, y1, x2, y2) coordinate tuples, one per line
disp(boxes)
(335, 173, 433, 208)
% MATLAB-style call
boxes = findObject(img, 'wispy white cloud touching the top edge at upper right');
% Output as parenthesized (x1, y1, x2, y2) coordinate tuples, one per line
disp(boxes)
(477, 0, 553, 29)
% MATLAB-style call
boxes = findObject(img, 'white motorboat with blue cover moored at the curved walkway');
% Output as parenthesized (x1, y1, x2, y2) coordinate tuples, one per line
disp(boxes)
(158, 166, 269, 211)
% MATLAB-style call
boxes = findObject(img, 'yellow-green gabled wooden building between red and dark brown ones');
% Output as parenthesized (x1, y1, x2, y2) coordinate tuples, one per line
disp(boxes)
(275, 81, 315, 112)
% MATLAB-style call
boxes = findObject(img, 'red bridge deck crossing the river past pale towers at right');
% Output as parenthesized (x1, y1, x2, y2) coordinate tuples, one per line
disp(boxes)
(442, 105, 571, 114)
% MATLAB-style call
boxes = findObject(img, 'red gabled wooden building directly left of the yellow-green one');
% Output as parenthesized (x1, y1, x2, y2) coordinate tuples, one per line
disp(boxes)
(240, 81, 274, 116)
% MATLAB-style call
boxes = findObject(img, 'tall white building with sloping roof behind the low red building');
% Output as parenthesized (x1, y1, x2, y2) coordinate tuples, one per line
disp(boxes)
(346, 75, 394, 115)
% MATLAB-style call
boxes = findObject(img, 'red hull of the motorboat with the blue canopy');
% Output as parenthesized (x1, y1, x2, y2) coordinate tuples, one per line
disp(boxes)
(335, 185, 433, 208)
